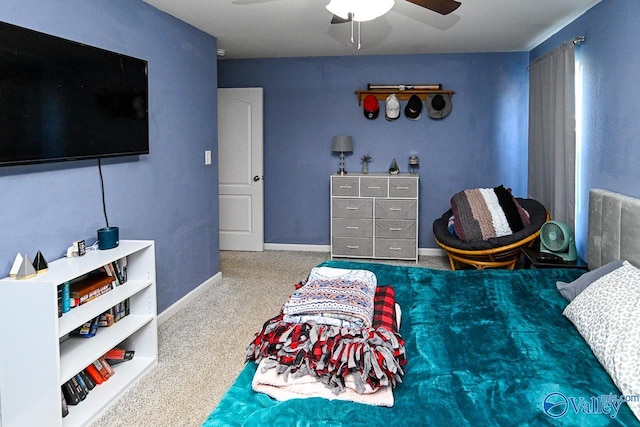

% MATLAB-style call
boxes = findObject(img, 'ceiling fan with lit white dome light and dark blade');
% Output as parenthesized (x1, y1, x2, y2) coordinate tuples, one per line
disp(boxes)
(327, 0, 462, 24)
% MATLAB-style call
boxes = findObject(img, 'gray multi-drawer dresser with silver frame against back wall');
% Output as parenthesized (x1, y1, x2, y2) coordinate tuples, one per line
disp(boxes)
(331, 174, 418, 262)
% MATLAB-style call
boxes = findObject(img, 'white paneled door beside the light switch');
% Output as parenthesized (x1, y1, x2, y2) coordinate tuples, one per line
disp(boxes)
(218, 88, 264, 251)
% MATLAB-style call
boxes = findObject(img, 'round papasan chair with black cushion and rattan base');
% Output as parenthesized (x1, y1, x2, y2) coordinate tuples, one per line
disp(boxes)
(433, 186, 549, 270)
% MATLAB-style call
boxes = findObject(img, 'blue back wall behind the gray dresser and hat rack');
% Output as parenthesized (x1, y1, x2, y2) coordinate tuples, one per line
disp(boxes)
(218, 52, 529, 251)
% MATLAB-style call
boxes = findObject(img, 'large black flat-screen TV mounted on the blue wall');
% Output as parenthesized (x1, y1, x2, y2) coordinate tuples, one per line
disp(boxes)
(0, 22, 149, 166)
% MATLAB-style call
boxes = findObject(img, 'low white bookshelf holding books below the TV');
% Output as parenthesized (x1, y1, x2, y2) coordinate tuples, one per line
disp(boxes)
(0, 240, 158, 427)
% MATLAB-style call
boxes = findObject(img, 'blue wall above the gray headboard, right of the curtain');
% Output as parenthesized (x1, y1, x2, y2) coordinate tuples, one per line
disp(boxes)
(531, 0, 640, 256)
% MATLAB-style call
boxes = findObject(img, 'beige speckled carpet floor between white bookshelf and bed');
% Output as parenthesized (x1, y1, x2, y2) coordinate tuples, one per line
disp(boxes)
(92, 251, 449, 427)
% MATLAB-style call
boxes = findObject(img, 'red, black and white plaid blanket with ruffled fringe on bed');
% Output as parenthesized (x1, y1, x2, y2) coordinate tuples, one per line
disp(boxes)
(247, 281, 407, 394)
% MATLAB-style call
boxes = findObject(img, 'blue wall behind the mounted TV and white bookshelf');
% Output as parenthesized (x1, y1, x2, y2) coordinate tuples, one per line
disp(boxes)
(0, 0, 220, 311)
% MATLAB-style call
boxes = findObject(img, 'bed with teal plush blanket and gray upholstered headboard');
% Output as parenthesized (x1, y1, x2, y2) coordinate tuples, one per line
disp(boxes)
(203, 190, 640, 427)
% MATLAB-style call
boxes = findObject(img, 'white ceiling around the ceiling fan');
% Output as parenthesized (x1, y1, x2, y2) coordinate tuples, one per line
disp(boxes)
(144, 0, 600, 58)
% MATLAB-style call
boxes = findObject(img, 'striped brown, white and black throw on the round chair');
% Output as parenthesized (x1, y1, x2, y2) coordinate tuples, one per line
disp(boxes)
(451, 185, 531, 242)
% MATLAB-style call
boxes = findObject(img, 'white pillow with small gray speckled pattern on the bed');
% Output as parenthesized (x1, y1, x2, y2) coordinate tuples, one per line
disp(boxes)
(563, 261, 640, 420)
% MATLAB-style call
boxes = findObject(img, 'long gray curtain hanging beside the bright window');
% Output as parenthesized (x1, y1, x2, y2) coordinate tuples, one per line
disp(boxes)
(528, 42, 576, 230)
